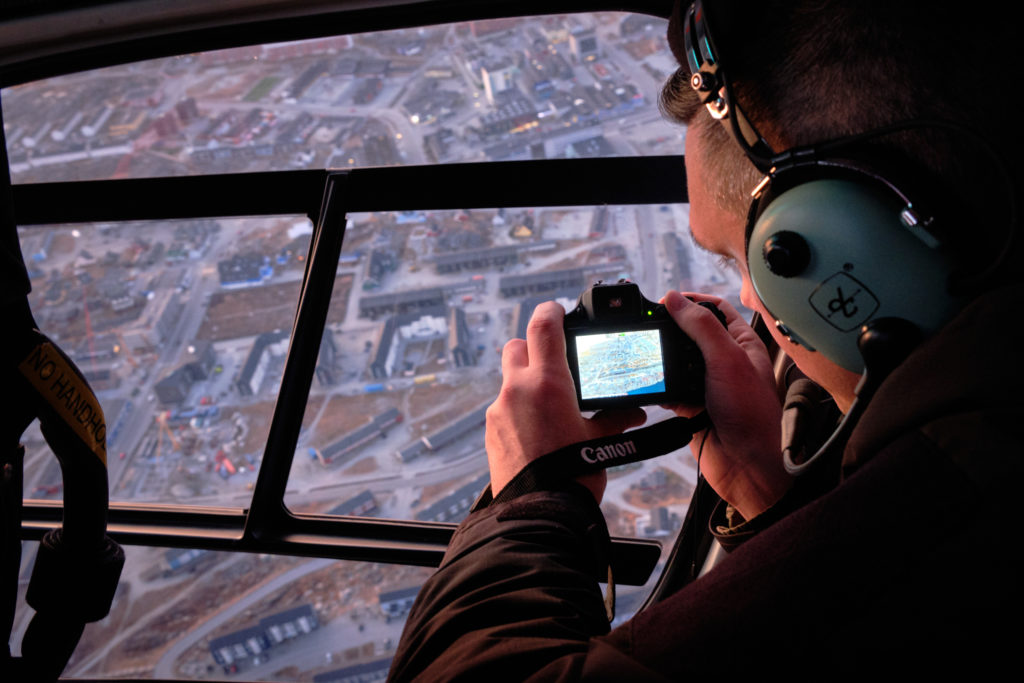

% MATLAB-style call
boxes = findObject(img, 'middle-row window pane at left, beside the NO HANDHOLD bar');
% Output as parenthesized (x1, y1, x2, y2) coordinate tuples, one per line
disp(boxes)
(14, 216, 311, 505)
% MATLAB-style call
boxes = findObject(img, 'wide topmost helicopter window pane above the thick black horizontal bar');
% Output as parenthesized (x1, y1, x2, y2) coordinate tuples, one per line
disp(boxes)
(2, 12, 679, 182)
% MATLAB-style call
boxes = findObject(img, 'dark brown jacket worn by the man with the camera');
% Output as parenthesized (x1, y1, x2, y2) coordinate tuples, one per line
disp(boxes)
(391, 288, 1024, 681)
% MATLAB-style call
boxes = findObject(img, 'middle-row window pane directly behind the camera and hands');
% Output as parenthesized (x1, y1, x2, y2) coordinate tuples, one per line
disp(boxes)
(285, 205, 739, 538)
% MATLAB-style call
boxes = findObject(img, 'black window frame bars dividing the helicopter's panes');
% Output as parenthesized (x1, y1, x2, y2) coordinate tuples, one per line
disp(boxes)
(0, 0, 692, 585)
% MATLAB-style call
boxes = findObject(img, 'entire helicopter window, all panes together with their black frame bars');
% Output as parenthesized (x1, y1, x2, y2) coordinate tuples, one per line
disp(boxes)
(0, 0, 761, 682)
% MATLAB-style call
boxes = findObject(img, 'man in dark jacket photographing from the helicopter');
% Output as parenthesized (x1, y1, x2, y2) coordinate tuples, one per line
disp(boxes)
(391, 0, 1024, 680)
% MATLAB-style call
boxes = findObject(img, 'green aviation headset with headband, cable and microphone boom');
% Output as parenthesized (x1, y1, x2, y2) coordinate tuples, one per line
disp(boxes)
(677, 0, 1016, 474)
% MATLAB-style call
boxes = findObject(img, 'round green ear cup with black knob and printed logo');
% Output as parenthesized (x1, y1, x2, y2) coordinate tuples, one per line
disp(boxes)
(746, 178, 962, 373)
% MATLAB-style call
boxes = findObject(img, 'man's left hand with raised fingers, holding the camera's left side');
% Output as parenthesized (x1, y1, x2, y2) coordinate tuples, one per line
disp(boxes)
(484, 301, 647, 503)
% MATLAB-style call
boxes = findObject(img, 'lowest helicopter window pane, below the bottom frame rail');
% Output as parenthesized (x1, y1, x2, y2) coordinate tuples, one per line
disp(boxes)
(15, 543, 430, 681)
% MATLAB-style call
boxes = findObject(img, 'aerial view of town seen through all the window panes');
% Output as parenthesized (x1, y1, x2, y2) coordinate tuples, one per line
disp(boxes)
(8, 13, 738, 682)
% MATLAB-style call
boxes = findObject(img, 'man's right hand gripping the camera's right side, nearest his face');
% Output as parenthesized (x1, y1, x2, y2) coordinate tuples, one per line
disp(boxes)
(663, 292, 792, 519)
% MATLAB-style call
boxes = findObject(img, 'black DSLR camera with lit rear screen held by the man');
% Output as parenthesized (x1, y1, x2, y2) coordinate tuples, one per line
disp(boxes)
(563, 280, 725, 411)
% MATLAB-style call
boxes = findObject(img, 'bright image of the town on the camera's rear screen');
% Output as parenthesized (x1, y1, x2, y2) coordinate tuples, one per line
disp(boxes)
(575, 330, 665, 399)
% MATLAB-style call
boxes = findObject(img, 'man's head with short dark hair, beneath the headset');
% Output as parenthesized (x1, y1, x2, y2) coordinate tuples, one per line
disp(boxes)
(662, 0, 1019, 405)
